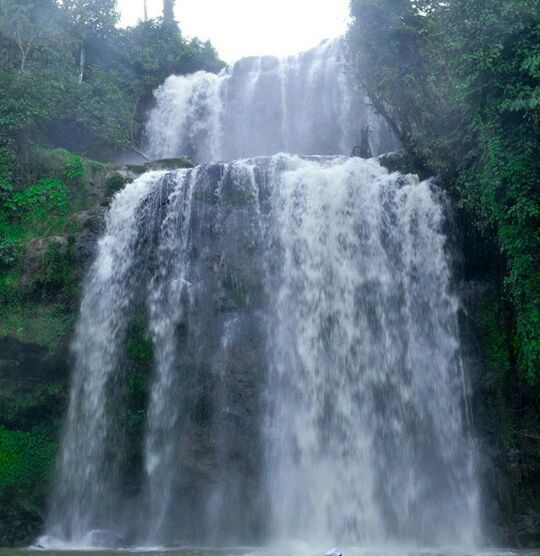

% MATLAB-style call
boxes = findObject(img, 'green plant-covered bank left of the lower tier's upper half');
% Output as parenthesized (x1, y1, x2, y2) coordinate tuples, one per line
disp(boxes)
(0, 149, 80, 351)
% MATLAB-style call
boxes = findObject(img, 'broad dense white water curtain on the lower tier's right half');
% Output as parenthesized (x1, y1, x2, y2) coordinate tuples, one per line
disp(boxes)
(266, 161, 478, 544)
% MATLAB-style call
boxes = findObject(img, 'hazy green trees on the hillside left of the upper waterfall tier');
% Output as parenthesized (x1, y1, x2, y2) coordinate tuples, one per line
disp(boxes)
(0, 0, 222, 161)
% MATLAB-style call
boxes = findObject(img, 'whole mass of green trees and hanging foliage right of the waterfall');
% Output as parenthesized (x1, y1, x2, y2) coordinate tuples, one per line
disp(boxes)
(349, 0, 540, 384)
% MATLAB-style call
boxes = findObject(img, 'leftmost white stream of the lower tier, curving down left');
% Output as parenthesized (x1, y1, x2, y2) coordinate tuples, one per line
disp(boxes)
(48, 172, 169, 541)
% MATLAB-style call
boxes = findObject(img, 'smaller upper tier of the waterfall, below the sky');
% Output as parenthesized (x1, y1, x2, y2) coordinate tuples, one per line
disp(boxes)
(144, 39, 397, 162)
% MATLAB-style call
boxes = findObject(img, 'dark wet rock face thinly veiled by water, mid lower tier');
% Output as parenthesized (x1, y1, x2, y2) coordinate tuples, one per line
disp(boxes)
(178, 175, 266, 540)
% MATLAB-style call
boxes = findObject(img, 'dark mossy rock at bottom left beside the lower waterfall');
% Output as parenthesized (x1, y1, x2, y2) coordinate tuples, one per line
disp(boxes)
(0, 332, 69, 546)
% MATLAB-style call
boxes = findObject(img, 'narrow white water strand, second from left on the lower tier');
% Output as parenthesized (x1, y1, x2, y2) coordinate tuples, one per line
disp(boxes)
(145, 167, 197, 539)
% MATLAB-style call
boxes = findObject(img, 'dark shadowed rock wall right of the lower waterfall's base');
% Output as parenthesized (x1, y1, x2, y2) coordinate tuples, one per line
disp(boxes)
(459, 274, 540, 548)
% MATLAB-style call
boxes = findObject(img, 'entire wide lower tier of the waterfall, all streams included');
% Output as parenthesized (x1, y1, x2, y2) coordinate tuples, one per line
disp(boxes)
(47, 155, 479, 546)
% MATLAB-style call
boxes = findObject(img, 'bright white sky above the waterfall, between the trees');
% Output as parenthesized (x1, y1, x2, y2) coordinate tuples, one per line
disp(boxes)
(119, 0, 349, 62)
